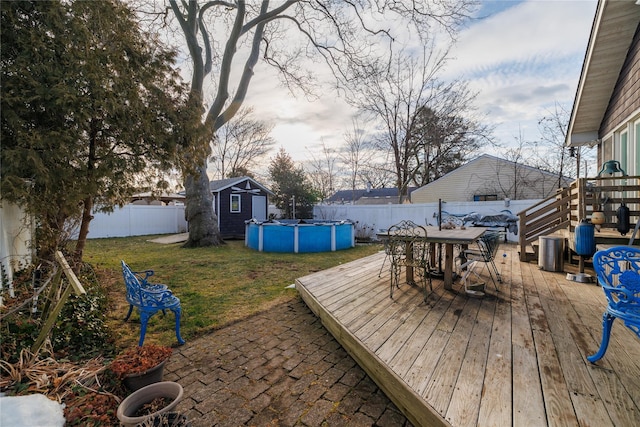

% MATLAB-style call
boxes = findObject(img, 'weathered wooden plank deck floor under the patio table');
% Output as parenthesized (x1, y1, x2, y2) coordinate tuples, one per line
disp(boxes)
(296, 245, 640, 427)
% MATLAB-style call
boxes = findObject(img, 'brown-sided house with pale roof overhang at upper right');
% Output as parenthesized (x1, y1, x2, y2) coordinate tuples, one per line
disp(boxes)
(566, 0, 640, 176)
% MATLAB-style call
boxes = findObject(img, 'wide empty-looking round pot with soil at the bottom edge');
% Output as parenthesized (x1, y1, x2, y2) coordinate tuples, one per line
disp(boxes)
(116, 381, 184, 426)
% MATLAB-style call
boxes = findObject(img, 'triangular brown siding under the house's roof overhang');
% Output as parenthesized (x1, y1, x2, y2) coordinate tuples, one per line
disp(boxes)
(599, 21, 640, 138)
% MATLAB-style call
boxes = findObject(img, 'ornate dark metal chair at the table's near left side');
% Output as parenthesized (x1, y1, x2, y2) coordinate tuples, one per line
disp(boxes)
(386, 220, 433, 302)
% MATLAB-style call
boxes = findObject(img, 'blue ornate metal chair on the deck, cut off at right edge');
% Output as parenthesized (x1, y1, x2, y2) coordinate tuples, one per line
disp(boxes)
(587, 246, 640, 363)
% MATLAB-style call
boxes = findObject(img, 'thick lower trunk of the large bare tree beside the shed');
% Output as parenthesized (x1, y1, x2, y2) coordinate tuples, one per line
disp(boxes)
(183, 162, 224, 248)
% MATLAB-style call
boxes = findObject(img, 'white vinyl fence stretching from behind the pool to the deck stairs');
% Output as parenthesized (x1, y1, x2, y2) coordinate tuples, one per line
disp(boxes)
(313, 200, 539, 242)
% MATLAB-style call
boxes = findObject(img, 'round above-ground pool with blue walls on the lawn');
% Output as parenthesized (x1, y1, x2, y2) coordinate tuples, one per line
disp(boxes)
(245, 220, 355, 253)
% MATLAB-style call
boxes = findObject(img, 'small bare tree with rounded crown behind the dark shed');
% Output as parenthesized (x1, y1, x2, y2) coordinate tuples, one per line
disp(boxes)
(211, 107, 275, 178)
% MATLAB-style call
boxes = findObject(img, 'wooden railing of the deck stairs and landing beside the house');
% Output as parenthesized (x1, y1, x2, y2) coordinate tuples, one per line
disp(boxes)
(518, 176, 640, 261)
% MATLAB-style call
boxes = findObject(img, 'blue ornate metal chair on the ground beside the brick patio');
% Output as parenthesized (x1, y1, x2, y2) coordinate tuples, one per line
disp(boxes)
(121, 261, 185, 346)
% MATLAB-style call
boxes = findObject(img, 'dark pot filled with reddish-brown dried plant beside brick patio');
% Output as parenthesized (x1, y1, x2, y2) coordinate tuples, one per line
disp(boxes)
(109, 344, 173, 391)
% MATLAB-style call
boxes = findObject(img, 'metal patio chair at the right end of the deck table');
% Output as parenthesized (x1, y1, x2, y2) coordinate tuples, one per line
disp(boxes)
(460, 231, 502, 295)
